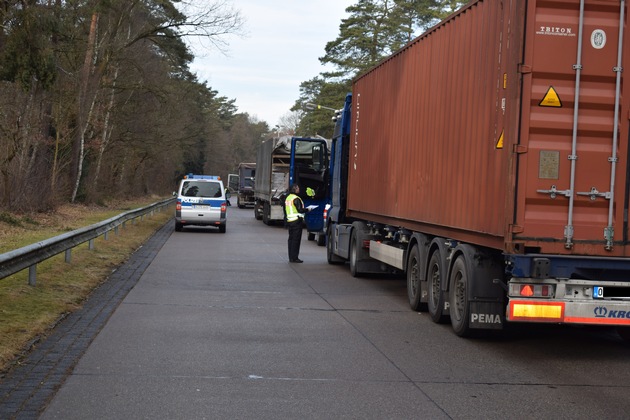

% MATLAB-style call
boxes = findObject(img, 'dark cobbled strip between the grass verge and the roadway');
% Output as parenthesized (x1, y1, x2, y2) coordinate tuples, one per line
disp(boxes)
(0, 222, 173, 419)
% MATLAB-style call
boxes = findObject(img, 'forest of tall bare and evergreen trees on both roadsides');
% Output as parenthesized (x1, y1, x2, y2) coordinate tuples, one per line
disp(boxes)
(0, 0, 462, 212)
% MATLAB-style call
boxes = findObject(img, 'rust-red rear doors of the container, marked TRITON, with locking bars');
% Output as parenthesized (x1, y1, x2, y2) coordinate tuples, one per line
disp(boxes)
(513, 0, 630, 256)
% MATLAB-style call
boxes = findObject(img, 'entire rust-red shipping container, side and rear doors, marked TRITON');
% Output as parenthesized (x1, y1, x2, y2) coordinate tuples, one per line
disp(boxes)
(348, 0, 630, 256)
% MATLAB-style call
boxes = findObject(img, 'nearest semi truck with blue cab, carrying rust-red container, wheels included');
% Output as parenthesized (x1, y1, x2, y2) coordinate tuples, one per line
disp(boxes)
(325, 0, 630, 340)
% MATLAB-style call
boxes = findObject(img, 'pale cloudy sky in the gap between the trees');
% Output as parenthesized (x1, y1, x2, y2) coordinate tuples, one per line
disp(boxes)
(186, 0, 357, 127)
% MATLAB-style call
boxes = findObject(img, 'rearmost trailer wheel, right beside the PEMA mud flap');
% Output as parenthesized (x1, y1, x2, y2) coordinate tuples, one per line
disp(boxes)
(448, 255, 471, 337)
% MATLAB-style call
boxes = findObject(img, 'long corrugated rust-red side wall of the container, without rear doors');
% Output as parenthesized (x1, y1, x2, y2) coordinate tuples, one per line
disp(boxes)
(348, 1, 508, 251)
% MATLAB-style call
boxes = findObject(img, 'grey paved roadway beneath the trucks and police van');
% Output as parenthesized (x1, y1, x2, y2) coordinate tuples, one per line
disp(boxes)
(3, 202, 630, 419)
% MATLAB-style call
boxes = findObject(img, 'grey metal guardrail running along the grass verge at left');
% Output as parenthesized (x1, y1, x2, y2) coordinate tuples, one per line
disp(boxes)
(0, 198, 176, 286)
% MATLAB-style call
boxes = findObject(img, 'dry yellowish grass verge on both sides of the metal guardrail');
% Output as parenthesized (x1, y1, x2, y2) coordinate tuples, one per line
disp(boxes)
(0, 197, 174, 372)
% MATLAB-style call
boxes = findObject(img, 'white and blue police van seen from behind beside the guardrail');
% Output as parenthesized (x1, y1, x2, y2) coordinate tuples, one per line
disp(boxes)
(173, 174, 229, 233)
